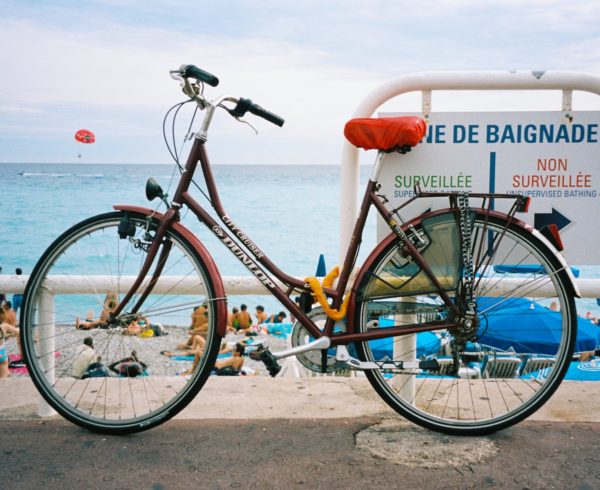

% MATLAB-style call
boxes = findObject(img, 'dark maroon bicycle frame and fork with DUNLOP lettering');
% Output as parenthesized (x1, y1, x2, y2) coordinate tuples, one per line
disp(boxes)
(114, 138, 458, 345)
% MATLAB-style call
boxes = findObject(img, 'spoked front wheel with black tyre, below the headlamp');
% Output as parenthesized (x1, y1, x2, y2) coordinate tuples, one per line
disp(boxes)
(21, 212, 223, 434)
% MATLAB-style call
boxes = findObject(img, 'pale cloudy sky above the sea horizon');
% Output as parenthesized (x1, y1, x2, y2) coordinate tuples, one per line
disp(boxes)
(0, 0, 600, 164)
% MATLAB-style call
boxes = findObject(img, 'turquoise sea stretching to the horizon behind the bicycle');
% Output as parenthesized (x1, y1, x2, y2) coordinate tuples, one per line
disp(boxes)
(0, 163, 600, 317)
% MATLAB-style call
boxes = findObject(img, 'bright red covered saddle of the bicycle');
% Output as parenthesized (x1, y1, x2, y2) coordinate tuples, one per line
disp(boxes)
(344, 116, 427, 153)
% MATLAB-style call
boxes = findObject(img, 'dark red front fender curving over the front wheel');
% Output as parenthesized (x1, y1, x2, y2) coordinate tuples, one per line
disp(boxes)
(113, 204, 227, 337)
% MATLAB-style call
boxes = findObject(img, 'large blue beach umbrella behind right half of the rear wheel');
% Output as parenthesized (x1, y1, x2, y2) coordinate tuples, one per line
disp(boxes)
(477, 297, 600, 355)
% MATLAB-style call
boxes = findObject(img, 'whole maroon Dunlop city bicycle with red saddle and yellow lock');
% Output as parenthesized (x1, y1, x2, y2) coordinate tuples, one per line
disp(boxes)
(21, 65, 578, 435)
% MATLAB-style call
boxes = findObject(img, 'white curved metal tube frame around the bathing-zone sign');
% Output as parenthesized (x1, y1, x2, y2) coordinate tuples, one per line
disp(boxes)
(339, 71, 600, 263)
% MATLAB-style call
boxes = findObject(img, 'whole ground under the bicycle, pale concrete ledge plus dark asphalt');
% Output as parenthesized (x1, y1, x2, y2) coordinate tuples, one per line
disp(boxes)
(0, 377, 600, 490)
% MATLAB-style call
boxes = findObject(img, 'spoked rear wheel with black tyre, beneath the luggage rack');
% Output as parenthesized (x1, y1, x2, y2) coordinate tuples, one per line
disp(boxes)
(355, 213, 576, 435)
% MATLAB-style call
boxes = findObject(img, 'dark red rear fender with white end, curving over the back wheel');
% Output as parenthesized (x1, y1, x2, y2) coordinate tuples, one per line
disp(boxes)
(346, 208, 581, 332)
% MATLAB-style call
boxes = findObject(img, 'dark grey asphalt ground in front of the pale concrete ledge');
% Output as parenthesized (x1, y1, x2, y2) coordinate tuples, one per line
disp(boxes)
(0, 417, 600, 490)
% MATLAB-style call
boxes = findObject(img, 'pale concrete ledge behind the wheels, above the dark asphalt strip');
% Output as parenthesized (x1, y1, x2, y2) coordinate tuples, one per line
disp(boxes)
(0, 376, 600, 423)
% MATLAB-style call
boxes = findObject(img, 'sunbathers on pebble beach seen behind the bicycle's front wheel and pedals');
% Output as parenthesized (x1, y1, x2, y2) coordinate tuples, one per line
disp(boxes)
(0, 276, 291, 378)
